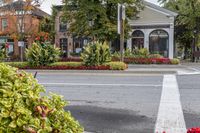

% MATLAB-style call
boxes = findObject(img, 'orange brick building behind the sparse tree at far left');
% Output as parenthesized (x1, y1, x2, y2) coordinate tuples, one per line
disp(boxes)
(0, 1, 49, 58)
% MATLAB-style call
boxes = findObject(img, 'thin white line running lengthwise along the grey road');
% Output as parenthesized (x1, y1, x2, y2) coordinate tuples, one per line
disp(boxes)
(39, 83, 162, 87)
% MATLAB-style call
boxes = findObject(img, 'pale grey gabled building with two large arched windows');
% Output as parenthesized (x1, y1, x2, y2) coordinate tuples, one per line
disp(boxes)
(127, 1, 178, 58)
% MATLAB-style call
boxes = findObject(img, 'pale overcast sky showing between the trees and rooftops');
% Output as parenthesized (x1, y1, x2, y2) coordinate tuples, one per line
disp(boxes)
(41, 0, 158, 14)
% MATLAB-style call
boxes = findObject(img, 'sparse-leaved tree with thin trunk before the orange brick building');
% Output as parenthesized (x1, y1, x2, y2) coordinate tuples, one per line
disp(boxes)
(0, 0, 42, 60)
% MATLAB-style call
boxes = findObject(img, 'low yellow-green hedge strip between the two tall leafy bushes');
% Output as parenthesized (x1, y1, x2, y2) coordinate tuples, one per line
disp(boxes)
(49, 62, 83, 67)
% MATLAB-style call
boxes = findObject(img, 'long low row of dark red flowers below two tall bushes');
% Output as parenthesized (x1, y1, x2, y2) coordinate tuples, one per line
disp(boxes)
(20, 66, 110, 70)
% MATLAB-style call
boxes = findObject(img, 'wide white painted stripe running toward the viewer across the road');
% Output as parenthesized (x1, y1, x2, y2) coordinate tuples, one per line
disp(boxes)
(155, 75, 187, 133)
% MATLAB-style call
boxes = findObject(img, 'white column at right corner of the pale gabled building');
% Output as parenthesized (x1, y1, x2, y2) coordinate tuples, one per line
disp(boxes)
(169, 23, 174, 59)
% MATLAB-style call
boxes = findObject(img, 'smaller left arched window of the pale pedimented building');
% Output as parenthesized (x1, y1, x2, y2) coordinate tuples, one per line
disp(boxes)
(132, 30, 144, 49)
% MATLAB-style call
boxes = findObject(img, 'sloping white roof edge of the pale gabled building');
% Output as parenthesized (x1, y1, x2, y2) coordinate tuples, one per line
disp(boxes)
(143, 1, 178, 17)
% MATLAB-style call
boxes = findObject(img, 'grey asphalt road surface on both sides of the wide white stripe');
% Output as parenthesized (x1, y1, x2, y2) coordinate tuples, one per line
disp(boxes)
(31, 72, 200, 133)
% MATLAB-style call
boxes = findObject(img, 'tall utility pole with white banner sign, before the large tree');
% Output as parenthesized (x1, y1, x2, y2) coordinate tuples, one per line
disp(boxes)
(118, 4, 126, 62)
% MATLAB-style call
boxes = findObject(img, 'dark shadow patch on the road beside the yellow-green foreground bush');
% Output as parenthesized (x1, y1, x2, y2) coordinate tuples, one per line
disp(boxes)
(65, 106, 155, 133)
